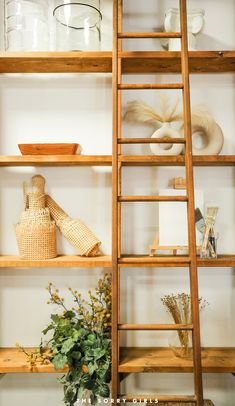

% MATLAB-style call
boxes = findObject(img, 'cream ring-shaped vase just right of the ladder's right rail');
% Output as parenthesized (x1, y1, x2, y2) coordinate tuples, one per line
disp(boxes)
(192, 123, 224, 155)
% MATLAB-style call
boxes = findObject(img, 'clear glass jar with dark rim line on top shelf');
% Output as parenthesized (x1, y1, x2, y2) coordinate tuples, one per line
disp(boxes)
(53, 0, 102, 51)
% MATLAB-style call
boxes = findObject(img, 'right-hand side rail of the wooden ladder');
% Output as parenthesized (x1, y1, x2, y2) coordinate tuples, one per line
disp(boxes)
(180, 0, 203, 406)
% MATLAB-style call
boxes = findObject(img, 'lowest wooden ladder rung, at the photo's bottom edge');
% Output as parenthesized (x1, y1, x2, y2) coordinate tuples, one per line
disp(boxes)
(118, 395, 197, 403)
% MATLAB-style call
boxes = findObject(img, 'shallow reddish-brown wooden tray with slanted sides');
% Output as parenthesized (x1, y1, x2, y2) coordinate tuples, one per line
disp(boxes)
(18, 144, 79, 155)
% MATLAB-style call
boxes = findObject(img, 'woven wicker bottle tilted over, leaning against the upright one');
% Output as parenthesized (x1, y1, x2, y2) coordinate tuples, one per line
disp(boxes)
(46, 195, 101, 257)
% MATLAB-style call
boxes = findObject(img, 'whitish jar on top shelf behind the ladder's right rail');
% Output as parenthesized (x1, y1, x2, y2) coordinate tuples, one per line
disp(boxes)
(162, 8, 205, 51)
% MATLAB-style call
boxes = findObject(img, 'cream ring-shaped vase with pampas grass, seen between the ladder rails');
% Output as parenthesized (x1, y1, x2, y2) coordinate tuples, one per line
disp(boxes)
(150, 123, 184, 155)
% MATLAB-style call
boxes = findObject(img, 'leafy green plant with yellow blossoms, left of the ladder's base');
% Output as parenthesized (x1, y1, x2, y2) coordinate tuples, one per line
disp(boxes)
(17, 274, 112, 406)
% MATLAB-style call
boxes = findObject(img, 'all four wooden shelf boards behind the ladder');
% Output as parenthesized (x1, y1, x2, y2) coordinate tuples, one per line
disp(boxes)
(0, 5, 235, 406)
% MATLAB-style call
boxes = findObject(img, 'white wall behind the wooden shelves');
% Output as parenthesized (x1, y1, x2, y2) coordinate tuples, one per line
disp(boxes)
(0, 0, 235, 406)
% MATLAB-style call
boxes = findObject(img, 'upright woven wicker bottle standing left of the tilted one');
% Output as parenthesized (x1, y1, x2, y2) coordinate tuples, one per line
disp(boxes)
(15, 175, 57, 260)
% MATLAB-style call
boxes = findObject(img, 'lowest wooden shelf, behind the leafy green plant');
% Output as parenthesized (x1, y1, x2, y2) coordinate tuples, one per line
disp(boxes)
(0, 347, 235, 374)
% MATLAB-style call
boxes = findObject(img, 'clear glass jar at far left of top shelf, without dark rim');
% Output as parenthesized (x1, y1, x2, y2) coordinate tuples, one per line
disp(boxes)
(5, 0, 49, 52)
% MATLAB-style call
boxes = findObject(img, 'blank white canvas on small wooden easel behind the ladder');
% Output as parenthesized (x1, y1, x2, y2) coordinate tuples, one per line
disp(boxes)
(159, 189, 204, 246)
